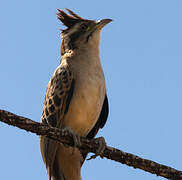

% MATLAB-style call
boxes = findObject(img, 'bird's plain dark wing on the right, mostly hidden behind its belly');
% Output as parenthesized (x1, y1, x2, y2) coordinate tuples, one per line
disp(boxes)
(82, 94, 109, 164)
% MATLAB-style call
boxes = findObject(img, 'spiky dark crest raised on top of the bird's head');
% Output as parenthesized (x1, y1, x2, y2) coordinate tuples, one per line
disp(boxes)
(57, 9, 86, 28)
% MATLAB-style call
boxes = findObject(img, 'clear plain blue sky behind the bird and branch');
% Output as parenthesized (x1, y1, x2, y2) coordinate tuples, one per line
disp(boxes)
(0, 0, 182, 180)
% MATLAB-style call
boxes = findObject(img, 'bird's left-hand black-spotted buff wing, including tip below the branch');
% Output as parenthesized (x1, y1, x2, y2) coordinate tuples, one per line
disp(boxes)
(40, 66, 74, 179)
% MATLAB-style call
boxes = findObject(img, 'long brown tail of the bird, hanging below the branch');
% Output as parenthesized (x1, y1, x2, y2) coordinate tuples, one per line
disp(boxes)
(40, 137, 83, 180)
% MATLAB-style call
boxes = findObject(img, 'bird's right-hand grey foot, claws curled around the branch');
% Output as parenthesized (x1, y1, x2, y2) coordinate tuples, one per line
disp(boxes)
(87, 137, 107, 160)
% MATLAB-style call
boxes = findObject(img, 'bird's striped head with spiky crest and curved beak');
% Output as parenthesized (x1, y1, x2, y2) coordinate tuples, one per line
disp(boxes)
(57, 9, 112, 55)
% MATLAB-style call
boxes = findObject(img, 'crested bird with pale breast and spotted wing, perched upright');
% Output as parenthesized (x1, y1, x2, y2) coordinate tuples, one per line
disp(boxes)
(40, 9, 112, 180)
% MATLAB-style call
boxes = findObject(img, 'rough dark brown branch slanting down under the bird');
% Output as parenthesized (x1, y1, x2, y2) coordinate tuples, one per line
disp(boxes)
(0, 110, 182, 180)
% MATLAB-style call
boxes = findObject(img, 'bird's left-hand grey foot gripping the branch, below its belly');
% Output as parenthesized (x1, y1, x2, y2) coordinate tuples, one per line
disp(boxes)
(63, 127, 81, 155)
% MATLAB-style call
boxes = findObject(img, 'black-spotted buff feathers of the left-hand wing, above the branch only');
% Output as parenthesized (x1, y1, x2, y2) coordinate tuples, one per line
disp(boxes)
(42, 66, 74, 127)
